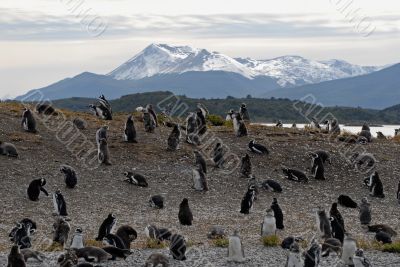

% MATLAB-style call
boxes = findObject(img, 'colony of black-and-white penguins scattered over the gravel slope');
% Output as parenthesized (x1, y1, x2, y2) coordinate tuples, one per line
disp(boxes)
(0, 99, 400, 267)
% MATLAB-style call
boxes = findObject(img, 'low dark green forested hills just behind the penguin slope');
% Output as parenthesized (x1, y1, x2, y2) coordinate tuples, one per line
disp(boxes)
(53, 92, 400, 124)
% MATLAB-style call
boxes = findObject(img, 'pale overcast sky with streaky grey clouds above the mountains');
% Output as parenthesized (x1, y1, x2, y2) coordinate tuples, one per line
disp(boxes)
(0, 0, 400, 98)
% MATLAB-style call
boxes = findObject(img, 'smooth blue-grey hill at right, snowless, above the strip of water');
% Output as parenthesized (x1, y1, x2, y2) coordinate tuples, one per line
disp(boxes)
(263, 64, 400, 109)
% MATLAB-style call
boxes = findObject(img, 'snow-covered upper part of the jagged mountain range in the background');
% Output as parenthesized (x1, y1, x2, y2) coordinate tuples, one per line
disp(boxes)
(108, 44, 381, 87)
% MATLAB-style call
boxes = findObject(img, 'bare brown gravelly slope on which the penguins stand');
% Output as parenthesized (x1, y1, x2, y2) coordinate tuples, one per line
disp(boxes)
(0, 103, 400, 266)
